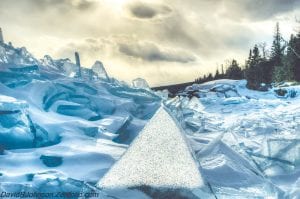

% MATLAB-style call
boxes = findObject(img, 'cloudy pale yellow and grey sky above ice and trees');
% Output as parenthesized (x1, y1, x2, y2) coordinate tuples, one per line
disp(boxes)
(0, 0, 300, 86)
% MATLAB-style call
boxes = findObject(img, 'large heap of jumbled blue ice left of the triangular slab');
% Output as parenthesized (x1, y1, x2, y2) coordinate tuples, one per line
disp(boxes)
(0, 44, 161, 198)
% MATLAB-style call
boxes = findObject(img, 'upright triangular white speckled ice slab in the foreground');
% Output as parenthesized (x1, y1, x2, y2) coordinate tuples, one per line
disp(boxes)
(98, 108, 203, 189)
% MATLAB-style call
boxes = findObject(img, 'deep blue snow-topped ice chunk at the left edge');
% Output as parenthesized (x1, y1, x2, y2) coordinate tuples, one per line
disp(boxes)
(0, 95, 58, 149)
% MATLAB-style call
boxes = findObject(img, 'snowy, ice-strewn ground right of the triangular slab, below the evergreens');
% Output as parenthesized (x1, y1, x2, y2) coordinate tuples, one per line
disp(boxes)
(166, 80, 300, 198)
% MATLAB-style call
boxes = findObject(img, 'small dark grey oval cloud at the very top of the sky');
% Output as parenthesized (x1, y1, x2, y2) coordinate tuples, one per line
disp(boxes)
(128, 2, 172, 19)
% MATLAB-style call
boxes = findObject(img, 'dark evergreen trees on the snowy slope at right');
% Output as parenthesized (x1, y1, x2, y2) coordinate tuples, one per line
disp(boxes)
(195, 23, 300, 90)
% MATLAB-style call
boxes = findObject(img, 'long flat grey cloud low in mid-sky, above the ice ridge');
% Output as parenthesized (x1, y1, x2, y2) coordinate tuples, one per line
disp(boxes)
(119, 42, 196, 63)
